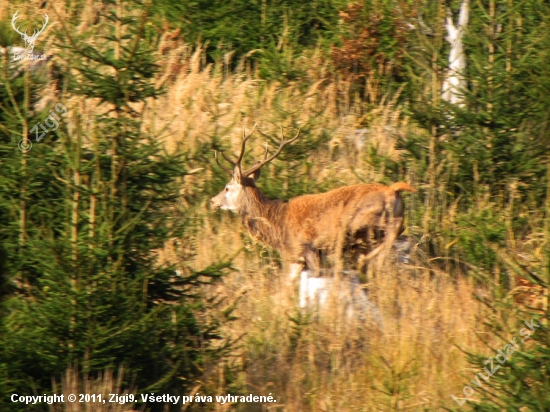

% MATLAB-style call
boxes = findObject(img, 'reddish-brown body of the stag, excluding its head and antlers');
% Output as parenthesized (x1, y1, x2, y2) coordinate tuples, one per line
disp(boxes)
(241, 182, 414, 271)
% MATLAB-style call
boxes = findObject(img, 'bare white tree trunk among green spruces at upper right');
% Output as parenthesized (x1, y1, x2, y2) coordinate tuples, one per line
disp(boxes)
(441, 0, 470, 106)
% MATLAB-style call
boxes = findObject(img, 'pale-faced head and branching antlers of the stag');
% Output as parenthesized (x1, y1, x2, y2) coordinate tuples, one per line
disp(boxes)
(210, 125, 300, 212)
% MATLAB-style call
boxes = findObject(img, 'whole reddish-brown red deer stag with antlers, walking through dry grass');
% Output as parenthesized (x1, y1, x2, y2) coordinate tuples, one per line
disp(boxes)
(210, 126, 415, 276)
